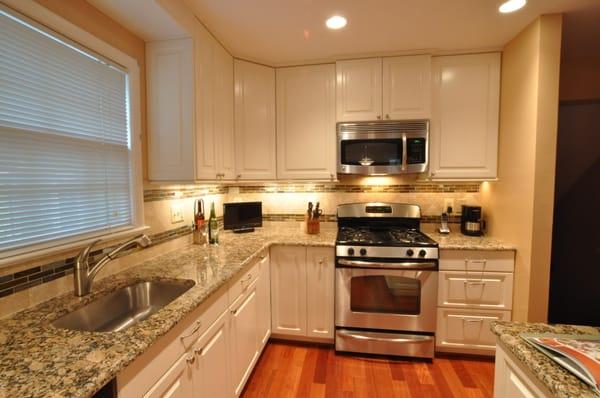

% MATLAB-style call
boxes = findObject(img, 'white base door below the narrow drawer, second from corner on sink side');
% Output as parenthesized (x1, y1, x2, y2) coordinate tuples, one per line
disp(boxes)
(229, 281, 258, 396)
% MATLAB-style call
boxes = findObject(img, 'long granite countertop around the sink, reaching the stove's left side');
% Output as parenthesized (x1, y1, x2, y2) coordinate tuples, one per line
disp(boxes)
(0, 223, 337, 398)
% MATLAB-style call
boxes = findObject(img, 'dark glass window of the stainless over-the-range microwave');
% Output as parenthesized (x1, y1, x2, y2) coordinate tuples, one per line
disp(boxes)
(341, 139, 402, 166)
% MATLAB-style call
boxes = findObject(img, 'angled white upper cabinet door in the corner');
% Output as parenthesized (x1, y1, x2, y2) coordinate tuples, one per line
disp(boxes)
(235, 59, 276, 180)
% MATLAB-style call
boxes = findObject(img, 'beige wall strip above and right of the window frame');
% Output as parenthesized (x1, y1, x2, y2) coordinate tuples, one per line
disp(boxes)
(34, 0, 148, 180)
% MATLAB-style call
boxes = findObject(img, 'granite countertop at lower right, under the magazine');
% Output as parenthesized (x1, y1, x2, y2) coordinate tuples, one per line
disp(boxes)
(492, 321, 600, 398)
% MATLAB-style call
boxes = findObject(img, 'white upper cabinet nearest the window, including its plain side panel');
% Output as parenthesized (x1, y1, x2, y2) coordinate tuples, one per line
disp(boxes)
(146, 22, 235, 181)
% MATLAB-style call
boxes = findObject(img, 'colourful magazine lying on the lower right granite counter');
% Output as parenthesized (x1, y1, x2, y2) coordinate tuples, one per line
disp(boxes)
(521, 333, 600, 394)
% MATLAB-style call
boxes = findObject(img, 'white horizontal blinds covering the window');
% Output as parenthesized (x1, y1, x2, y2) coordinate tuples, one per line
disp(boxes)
(0, 8, 133, 257)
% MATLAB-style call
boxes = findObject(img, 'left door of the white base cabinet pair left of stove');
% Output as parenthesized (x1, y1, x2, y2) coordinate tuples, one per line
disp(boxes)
(271, 246, 306, 336)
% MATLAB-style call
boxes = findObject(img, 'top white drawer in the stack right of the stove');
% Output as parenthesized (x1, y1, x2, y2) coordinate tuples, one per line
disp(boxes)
(440, 250, 515, 272)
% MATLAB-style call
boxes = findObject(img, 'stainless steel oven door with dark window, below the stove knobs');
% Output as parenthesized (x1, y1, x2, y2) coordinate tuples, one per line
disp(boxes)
(335, 268, 438, 333)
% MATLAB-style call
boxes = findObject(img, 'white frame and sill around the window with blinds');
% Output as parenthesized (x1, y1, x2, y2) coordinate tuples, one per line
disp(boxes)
(0, 0, 148, 266)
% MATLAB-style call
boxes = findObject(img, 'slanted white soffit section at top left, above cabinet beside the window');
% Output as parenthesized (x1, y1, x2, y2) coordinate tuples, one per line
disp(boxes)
(87, 0, 187, 41)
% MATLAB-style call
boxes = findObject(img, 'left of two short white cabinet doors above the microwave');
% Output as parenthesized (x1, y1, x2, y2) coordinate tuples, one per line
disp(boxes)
(335, 58, 382, 122)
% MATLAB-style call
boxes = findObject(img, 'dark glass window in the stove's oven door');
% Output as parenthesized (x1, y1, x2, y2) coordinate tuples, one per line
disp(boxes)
(350, 275, 421, 315)
